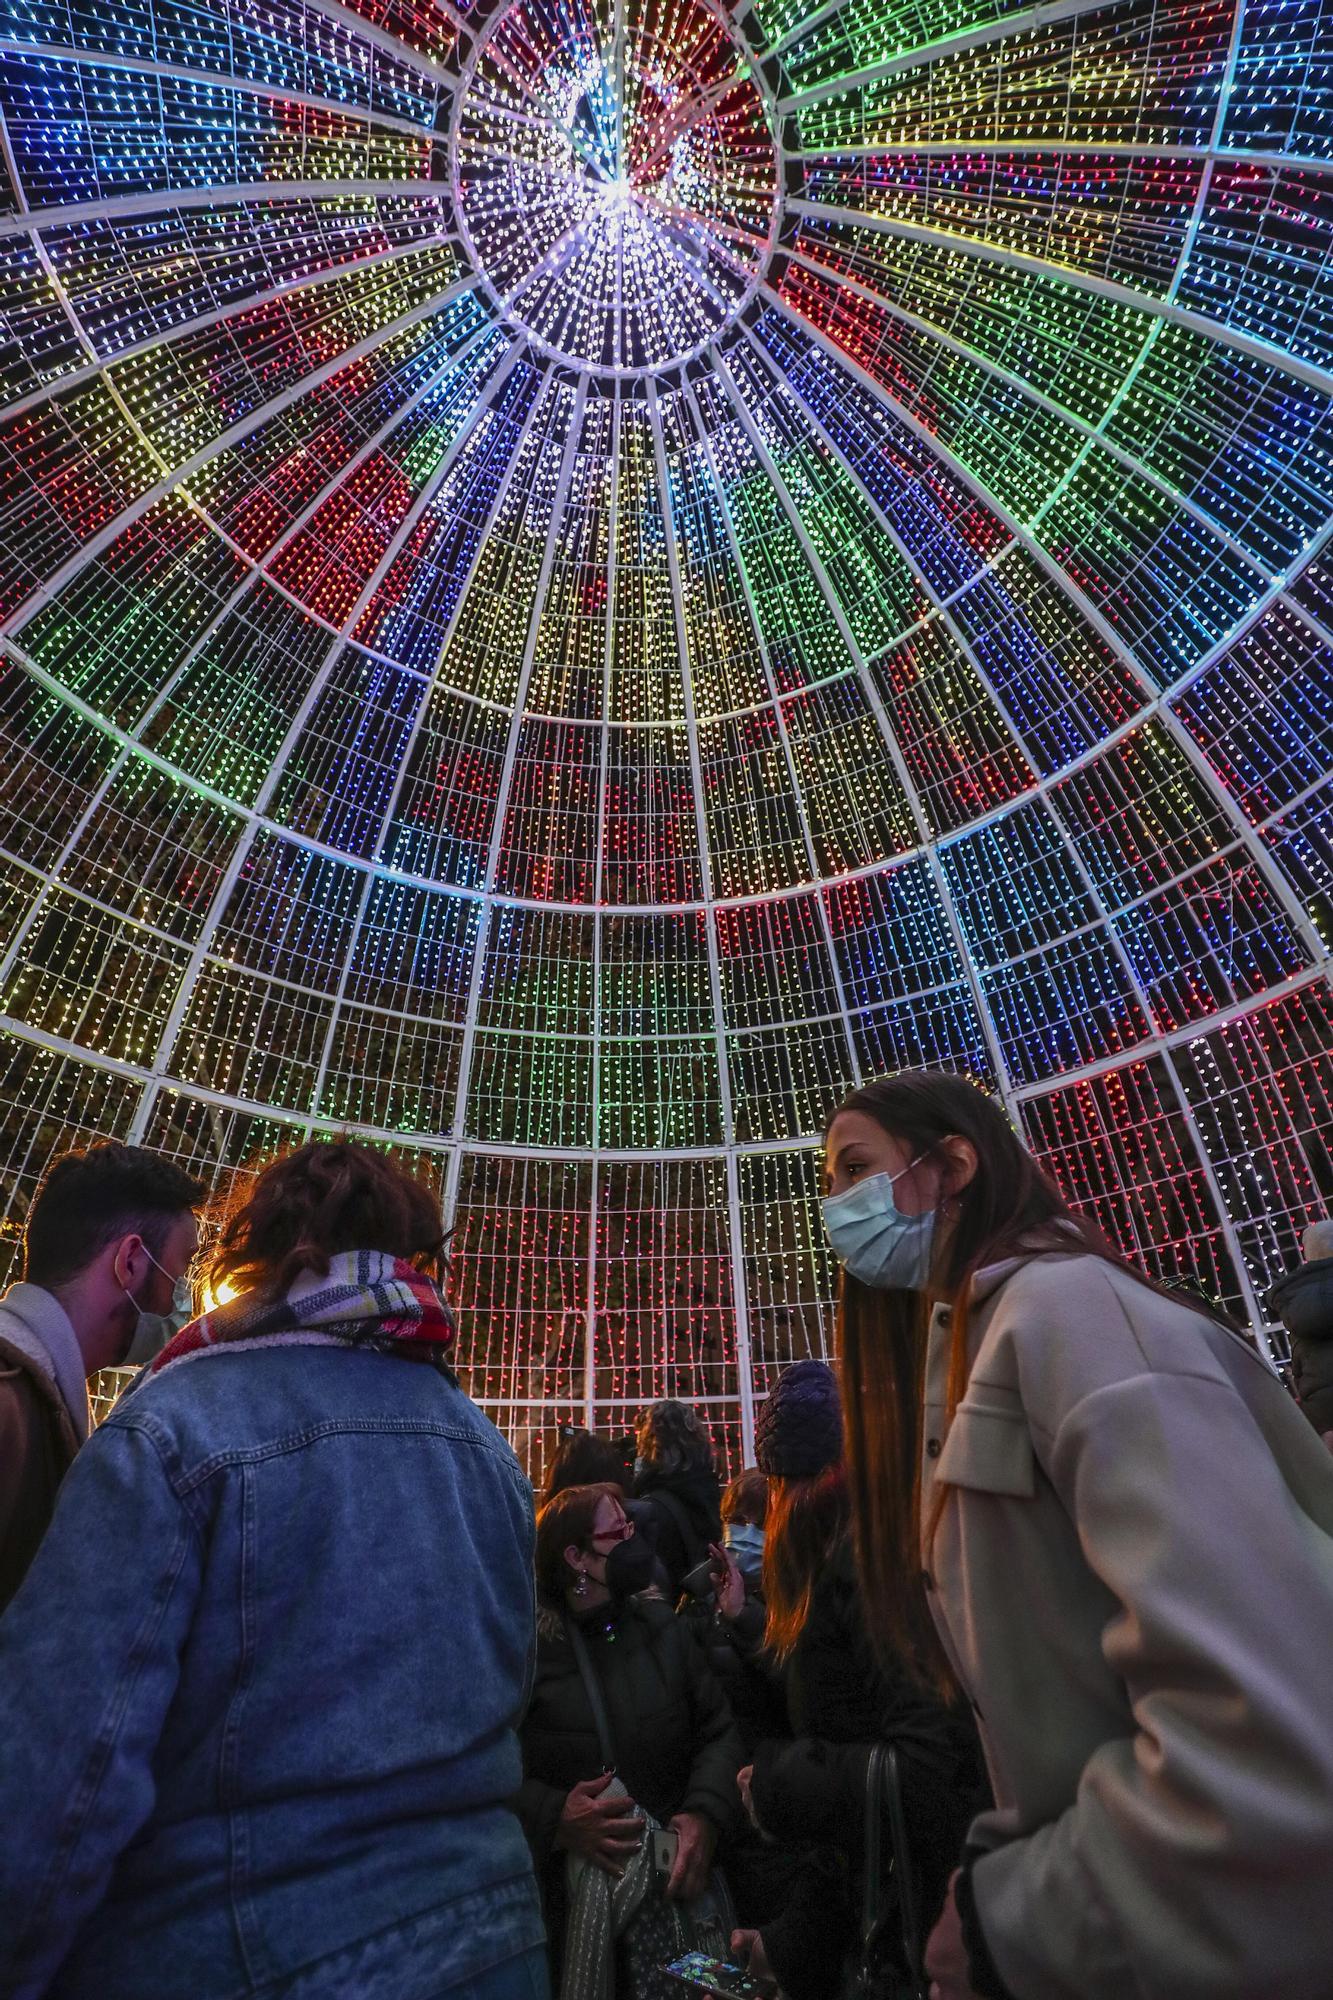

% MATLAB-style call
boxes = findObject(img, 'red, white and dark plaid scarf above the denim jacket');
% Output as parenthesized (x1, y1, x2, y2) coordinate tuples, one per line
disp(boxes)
(140, 1250, 454, 1382)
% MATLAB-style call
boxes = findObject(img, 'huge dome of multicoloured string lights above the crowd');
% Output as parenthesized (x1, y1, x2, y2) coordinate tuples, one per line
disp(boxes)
(0, 0, 1333, 1470)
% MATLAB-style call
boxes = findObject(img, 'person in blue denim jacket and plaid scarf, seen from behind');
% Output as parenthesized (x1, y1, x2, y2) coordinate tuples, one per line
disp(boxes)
(0, 1144, 546, 2000)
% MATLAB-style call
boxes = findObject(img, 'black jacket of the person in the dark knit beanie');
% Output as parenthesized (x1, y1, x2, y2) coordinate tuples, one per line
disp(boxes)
(753, 1542, 989, 2000)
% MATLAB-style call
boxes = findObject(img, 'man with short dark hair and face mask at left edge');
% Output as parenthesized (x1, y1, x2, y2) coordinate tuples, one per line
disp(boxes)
(0, 1144, 208, 1610)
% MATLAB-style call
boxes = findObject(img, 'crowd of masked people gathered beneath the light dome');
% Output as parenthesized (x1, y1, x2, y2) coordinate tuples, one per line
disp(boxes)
(0, 1072, 1333, 2000)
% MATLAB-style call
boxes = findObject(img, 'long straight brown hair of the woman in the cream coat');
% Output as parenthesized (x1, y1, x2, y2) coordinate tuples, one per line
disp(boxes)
(825, 1070, 1211, 1692)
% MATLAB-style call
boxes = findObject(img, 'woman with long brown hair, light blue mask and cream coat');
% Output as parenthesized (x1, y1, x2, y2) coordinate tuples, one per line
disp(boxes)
(825, 1072, 1333, 2000)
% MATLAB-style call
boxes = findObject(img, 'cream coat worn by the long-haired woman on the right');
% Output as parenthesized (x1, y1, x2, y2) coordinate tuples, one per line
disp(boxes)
(923, 1254, 1333, 2000)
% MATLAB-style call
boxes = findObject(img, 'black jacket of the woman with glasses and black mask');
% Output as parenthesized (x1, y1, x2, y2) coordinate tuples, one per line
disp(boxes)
(516, 1598, 743, 1870)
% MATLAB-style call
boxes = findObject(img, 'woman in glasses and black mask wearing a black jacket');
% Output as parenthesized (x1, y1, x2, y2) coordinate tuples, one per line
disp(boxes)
(516, 1486, 743, 1974)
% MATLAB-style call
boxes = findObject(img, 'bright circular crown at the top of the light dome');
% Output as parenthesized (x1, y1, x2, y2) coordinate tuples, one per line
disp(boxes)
(450, 0, 779, 374)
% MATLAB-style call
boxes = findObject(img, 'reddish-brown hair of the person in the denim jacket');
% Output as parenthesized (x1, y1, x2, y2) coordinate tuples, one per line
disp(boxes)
(208, 1140, 444, 1298)
